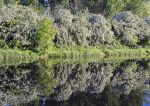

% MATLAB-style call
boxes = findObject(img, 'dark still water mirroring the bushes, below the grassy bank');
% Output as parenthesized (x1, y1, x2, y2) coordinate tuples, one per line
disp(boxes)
(0, 59, 150, 106)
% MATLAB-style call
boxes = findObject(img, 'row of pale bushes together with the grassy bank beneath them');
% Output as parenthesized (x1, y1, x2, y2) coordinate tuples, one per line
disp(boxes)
(0, 5, 150, 60)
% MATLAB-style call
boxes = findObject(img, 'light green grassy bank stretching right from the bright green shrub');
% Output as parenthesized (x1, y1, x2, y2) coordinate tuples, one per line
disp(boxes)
(46, 47, 150, 59)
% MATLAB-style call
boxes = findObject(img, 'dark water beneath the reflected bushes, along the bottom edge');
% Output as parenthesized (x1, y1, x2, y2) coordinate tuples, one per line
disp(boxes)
(46, 86, 142, 106)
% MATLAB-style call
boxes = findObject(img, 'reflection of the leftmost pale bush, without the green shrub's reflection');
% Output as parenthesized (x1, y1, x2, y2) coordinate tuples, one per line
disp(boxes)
(0, 64, 38, 105)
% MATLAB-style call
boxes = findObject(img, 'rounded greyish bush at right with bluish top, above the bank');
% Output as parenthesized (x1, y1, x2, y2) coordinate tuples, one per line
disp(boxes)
(112, 12, 150, 46)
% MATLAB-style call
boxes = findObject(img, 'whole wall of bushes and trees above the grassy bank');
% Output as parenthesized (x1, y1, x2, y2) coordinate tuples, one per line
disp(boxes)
(0, 0, 150, 56)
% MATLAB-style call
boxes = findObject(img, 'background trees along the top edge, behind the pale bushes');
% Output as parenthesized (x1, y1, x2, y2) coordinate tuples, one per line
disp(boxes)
(2, 0, 149, 16)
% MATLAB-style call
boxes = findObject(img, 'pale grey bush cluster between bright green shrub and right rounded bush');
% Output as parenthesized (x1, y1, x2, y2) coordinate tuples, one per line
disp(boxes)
(55, 9, 114, 46)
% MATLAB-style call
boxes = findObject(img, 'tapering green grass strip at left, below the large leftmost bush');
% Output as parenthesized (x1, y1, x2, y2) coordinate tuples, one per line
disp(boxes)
(0, 49, 40, 66)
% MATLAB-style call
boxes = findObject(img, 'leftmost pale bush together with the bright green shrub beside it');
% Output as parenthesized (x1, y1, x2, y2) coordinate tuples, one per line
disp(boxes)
(0, 5, 55, 50)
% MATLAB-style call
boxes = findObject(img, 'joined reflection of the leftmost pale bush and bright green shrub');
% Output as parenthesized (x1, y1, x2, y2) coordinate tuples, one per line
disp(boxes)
(0, 63, 54, 106)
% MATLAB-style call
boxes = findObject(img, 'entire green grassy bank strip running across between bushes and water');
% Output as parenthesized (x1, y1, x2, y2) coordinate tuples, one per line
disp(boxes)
(0, 47, 150, 61)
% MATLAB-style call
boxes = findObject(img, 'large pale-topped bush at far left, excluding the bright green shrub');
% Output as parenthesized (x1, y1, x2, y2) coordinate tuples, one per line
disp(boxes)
(0, 5, 43, 50)
